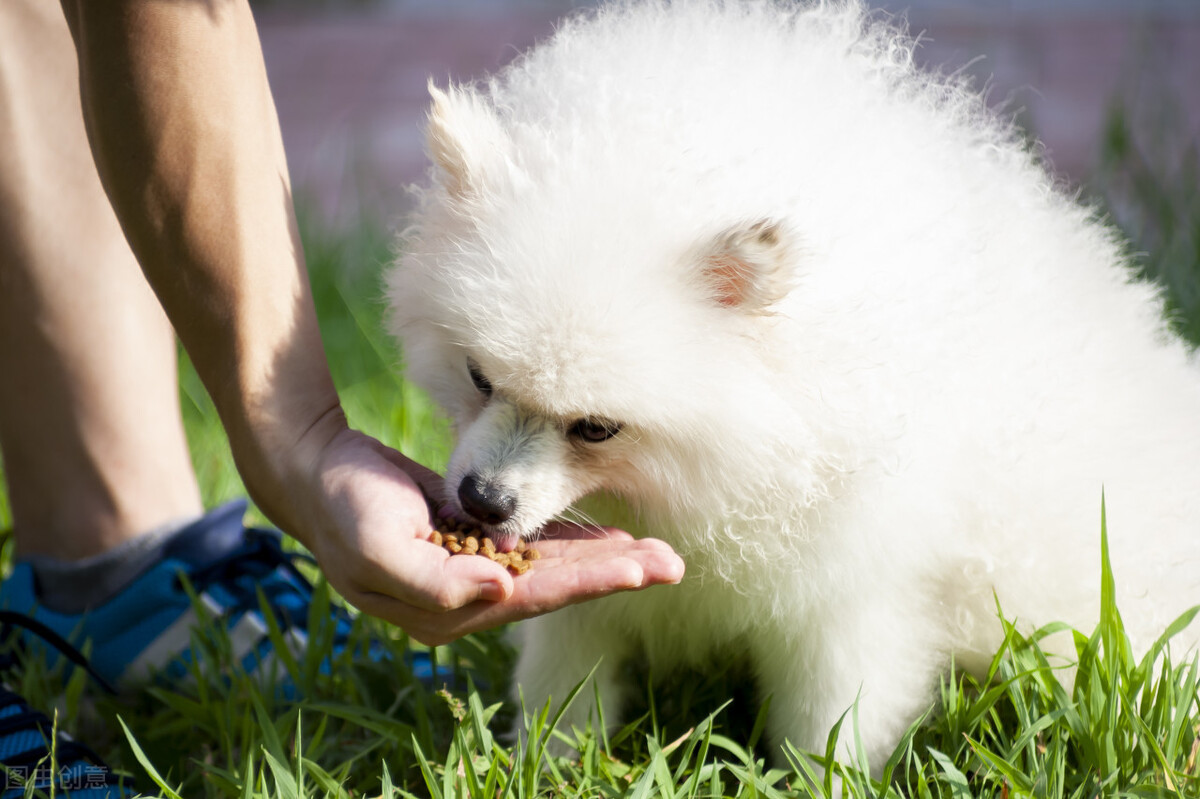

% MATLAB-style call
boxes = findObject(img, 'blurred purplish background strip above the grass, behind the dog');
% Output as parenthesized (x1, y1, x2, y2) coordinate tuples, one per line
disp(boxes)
(256, 0, 1200, 227)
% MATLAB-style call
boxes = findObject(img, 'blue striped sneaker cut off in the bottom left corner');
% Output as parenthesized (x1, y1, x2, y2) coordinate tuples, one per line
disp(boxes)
(0, 686, 133, 799)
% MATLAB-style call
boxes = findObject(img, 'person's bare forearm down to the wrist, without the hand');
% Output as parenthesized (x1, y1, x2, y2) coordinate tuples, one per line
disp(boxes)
(64, 0, 344, 542)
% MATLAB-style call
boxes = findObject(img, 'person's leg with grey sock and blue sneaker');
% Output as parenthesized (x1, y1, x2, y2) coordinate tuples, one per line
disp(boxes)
(0, 0, 446, 686)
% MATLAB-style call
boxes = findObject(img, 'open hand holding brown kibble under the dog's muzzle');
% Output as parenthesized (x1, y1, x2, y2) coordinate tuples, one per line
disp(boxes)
(269, 419, 684, 645)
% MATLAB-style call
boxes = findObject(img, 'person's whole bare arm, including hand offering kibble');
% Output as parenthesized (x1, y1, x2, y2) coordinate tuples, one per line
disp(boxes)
(56, 0, 682, 642)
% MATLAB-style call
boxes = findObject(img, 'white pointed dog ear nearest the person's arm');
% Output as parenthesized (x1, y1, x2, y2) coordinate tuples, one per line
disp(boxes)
(425, 80, 509, 199)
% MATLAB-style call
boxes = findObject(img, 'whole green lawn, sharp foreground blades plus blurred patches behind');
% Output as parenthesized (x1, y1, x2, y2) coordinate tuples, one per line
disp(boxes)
(0, 79, 1200, 799)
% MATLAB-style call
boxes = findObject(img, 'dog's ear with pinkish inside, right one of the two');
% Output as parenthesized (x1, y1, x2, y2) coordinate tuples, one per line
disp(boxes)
(701, 220, 794, 313)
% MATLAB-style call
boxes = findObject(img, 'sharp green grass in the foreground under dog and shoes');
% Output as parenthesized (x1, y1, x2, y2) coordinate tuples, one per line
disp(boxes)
(4, 491, 1200, 799)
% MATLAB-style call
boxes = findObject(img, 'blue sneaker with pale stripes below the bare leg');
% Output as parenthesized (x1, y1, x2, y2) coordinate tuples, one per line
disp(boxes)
(0, 501, 433, 687)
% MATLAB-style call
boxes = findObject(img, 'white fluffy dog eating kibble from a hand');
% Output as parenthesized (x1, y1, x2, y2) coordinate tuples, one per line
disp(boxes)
(389, 0, 1200, 763)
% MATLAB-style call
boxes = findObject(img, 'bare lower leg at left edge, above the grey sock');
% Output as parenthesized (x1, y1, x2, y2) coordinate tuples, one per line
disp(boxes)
(0, 2, 202, 560)
